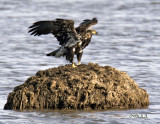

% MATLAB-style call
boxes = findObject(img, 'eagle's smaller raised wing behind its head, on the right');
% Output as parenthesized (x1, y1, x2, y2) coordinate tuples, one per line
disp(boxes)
(76, 18, 98, 33)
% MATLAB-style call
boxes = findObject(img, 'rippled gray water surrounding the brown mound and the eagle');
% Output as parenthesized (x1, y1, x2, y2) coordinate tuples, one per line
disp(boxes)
(0, 0, 160, 124)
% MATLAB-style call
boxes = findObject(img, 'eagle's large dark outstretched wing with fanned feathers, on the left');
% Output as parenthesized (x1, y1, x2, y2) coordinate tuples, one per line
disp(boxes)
(29, 19, 79, 47)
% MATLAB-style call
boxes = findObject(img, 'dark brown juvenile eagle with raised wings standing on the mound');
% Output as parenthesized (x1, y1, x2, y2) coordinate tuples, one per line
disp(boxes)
(29, 18, 98, 67)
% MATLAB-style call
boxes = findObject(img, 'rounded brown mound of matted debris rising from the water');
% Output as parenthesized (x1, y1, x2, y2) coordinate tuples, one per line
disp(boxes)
(4, 63, 149, 110)
